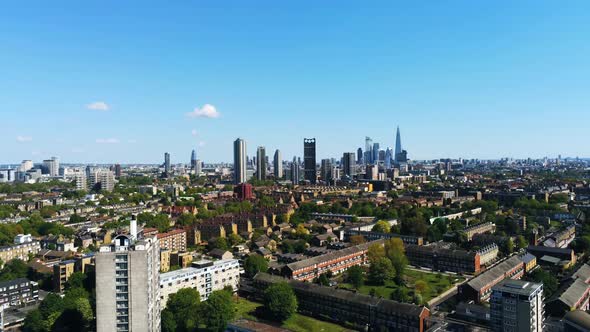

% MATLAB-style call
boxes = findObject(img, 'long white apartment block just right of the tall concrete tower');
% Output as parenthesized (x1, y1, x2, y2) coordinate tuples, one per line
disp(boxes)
(160, 259, 240, 309)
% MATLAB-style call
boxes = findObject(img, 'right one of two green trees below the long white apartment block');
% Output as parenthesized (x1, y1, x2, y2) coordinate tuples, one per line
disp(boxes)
(202, 290, 235, 332)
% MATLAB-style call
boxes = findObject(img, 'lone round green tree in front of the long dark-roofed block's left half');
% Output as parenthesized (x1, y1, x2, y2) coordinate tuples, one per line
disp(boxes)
(264, 282, 297, 322)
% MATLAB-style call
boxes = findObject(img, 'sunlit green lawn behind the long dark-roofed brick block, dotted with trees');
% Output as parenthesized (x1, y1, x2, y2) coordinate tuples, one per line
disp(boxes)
(338, 269, 464, 303)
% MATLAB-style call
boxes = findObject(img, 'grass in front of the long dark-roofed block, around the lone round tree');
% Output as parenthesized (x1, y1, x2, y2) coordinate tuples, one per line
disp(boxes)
(235, 297, 350, 332)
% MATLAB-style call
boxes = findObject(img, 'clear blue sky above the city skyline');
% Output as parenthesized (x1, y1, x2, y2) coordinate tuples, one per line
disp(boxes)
(0, 1, 590, 164)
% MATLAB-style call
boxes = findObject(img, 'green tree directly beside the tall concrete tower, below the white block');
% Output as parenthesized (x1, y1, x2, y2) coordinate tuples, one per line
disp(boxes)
(165, 288, 201, 332)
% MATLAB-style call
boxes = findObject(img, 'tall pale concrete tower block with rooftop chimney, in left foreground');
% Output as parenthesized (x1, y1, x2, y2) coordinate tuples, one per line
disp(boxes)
(96, 220, 161, 332)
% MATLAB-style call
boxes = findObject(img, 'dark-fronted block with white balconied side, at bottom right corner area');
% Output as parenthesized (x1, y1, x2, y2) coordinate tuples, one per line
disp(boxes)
(490, 279, 544, 332)
